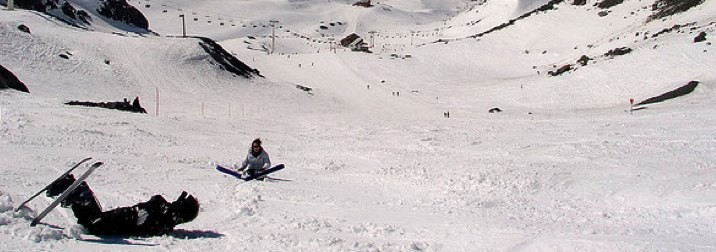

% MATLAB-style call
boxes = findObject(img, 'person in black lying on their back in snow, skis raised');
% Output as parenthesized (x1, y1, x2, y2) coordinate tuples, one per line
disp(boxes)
(46, 174, 199, 236)
